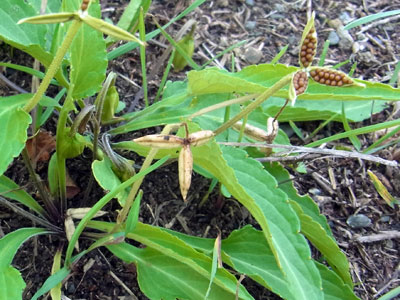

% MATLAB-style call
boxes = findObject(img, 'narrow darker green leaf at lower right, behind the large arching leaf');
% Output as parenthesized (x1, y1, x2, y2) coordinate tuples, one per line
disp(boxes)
(290, 201, 353, 287)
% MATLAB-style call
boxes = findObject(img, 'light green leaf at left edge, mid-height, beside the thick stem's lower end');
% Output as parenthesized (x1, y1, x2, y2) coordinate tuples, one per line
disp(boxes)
(0, 95, 32, 175)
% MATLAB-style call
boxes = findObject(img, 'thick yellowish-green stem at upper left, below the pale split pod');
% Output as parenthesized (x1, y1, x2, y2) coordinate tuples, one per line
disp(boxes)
(24, 19, 82, 112)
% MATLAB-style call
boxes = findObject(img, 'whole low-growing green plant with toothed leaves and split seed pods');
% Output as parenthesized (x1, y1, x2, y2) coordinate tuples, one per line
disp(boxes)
(0, 0, 400, 300)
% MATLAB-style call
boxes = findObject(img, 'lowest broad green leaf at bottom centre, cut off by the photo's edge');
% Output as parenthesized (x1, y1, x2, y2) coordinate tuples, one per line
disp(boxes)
(107, 243, 253, 300)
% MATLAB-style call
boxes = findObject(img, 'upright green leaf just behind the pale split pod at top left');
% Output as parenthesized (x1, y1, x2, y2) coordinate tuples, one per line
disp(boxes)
(69, 3, 108, 99)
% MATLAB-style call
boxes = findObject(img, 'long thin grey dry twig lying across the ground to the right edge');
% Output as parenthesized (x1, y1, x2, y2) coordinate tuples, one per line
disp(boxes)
(219, 142, 399, 167)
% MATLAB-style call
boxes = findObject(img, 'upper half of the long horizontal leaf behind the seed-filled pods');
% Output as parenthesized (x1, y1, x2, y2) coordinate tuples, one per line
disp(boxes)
(188, 64, 400, 101)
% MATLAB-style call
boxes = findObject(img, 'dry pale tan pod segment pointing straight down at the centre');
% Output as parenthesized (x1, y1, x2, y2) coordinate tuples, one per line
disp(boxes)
(178, 144, 193, 201)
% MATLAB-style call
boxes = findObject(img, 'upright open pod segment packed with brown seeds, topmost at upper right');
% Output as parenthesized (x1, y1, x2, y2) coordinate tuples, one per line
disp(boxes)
(299, 13, 317, 68)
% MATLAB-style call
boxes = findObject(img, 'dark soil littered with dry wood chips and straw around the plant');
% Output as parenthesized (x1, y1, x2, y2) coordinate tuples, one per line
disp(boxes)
(0, 0, 400, 299)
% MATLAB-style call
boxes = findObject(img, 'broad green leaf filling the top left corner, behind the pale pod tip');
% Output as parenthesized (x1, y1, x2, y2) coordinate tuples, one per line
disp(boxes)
(0, 0, 68, 86)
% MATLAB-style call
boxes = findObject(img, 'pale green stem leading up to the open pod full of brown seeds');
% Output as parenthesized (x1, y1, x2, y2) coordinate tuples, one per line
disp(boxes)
(214, 74, 293, 135)
